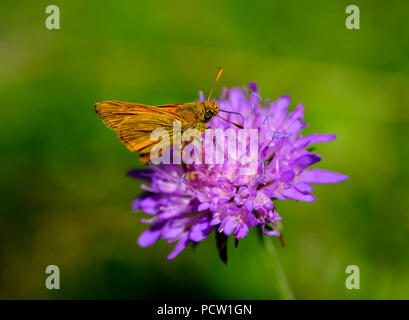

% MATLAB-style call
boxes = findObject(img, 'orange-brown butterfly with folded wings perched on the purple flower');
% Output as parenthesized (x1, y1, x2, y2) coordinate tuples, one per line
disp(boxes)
(94, 68, 243, 163)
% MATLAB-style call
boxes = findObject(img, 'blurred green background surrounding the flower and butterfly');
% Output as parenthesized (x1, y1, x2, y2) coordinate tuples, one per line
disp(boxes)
(0, 0, 409, 299)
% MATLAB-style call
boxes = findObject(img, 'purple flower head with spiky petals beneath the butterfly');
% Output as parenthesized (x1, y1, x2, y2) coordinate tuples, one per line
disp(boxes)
(130, 83, 348, 259)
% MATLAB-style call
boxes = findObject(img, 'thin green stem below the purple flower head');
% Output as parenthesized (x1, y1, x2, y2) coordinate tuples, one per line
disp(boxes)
(263, 236, 294, 300)
